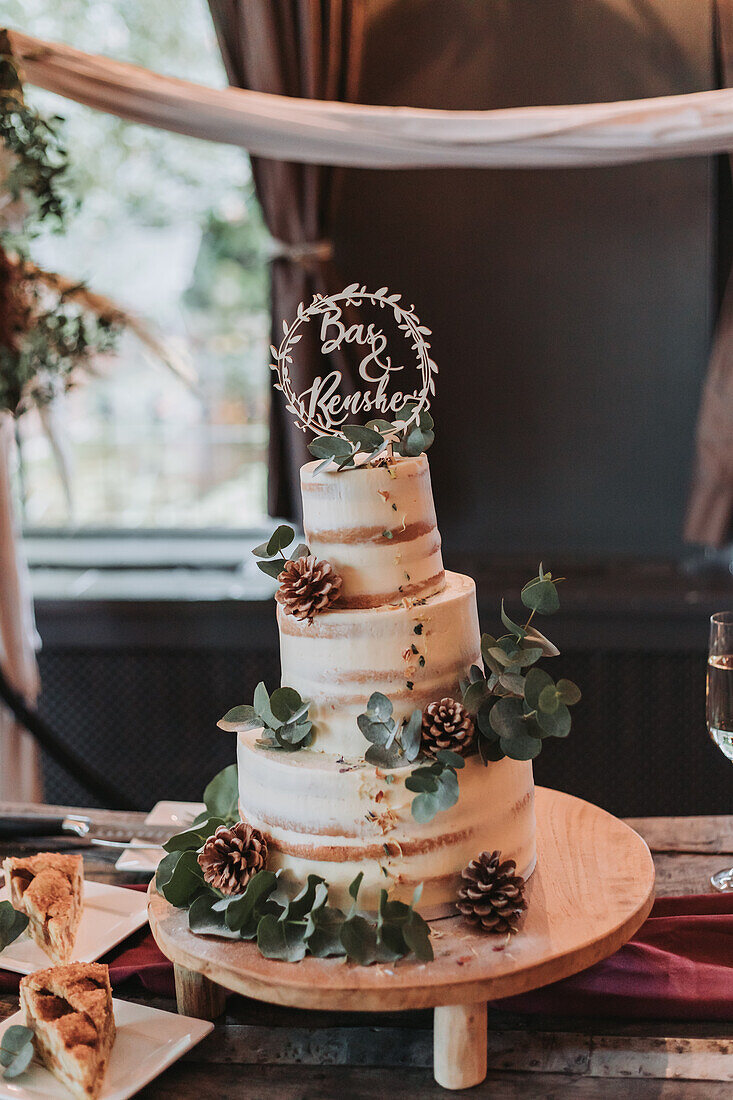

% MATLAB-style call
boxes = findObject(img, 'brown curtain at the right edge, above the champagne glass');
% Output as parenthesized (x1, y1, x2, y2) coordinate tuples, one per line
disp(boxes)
(685, 0, 733, 547)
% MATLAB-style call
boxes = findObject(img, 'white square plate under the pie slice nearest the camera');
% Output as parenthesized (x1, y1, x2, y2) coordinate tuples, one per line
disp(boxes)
(0, 999, 214, 1100)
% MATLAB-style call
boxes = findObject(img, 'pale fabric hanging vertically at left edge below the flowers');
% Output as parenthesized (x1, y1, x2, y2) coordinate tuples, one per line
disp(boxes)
(0, 414, 42, 802)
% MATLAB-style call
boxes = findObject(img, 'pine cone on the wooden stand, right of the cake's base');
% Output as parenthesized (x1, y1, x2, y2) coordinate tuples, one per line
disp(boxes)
(457, 851, 527, 935)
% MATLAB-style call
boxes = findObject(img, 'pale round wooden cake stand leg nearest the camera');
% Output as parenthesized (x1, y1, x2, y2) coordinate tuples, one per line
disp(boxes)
(433, 1001, 486, 1089)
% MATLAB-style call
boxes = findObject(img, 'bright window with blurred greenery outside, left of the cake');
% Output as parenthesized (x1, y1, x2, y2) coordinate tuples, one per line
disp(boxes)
(7, 0, 269, 530)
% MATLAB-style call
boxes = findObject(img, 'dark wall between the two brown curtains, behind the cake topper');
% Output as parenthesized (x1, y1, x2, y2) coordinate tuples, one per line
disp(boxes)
(335, 0, 716, 563)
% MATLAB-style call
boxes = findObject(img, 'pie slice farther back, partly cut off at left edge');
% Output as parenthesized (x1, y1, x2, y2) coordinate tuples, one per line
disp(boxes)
(2, 851, 84, 963)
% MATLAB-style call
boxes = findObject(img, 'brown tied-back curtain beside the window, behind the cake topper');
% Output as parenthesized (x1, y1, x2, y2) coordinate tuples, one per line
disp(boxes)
(209, 0, 364, 518)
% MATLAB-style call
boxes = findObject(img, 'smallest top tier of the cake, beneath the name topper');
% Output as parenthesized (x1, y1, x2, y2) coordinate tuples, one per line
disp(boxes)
(300, 454, 446, 607)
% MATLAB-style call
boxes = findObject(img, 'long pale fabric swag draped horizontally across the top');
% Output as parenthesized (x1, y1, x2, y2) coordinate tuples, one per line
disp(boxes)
(11, 31, 733, 168)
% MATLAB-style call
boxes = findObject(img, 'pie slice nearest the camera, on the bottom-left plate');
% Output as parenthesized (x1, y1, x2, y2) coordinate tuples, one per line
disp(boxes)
(20, 963, 114, 1100)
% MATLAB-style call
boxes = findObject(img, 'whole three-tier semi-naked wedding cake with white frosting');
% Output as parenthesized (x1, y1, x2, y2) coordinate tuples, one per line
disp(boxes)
(238, 453, 536, 917)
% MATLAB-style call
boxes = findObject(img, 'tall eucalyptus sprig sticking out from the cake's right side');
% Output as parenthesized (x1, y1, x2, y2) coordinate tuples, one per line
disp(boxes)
(461, 562, 581, 765)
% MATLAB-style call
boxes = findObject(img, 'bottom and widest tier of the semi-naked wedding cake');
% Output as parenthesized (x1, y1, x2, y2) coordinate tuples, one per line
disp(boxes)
(237, 730, 536, 919)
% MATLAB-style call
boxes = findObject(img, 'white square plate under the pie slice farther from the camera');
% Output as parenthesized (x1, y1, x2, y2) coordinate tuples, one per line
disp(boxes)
(0, 879, 147, 974)
